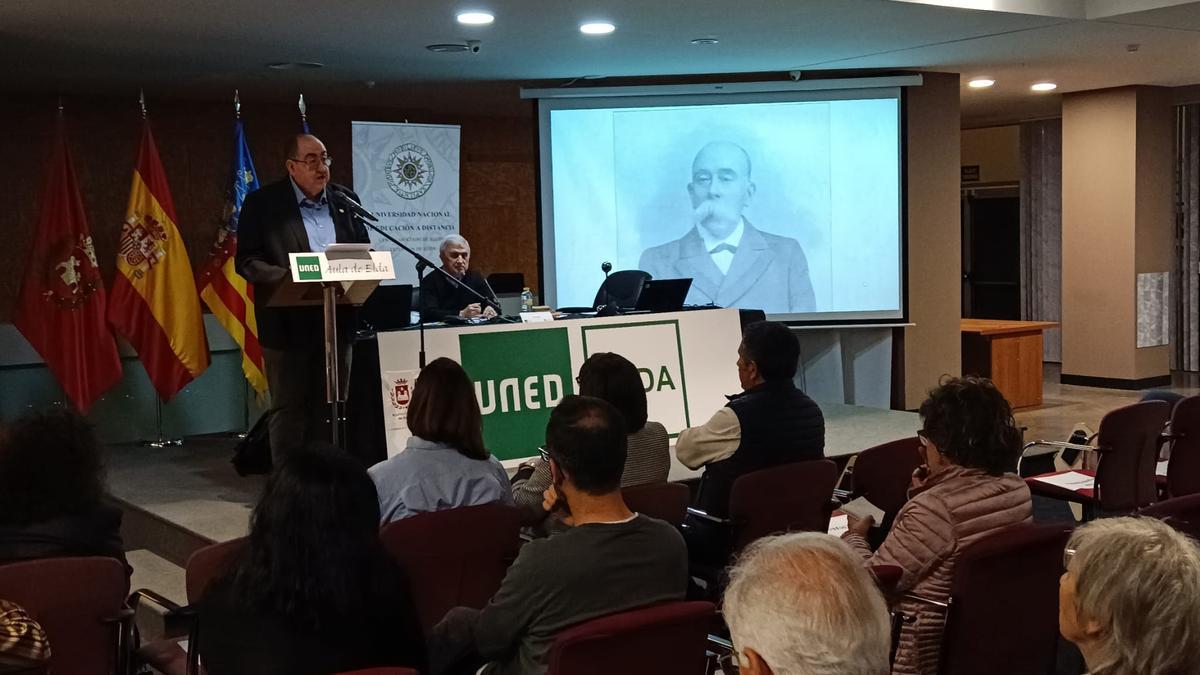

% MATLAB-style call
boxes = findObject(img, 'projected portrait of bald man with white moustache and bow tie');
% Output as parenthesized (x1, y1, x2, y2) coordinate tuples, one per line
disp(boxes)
(638, 141, 816, 313)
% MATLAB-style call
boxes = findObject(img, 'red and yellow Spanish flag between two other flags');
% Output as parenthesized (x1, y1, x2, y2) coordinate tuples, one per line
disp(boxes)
(108, 123, 209, 401)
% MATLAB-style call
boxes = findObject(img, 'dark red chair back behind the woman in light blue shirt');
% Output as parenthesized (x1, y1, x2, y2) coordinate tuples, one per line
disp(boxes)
(379, 504, 521, 632)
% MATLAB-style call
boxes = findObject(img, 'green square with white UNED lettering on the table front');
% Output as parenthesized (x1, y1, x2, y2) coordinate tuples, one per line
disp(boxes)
(458, 328, 575, 459)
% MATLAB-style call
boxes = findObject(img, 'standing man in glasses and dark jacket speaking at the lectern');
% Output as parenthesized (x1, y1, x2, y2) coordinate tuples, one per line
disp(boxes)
(238, 133, 370, 466)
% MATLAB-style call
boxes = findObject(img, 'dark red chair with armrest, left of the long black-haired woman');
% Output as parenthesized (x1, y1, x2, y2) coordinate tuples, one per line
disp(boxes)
(133, 537, 246, 675)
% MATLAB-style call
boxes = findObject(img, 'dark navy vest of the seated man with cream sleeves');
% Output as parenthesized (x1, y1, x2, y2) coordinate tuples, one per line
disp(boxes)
(696, 380, 824, 518)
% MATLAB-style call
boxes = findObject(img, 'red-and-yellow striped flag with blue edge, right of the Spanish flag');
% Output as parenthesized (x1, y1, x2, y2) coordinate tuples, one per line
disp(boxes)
(196, 113, 266, 394)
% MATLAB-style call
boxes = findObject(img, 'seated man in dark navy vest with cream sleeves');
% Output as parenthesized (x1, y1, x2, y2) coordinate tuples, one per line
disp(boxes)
(676, 321, 824, 563)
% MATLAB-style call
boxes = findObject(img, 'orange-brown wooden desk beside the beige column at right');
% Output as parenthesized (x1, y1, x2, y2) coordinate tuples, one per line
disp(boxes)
(962, 318, 1058, 408)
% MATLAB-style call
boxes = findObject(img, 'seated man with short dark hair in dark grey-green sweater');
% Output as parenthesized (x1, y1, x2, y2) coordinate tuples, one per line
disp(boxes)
(430, 396, 688, 675)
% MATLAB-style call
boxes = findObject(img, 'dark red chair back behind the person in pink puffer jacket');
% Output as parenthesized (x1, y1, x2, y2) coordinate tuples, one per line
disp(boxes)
(941, 525, 1070, 675)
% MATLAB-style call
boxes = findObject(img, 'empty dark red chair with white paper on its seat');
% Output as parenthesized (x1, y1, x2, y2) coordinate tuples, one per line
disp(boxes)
(1025, 401, 1170, 520)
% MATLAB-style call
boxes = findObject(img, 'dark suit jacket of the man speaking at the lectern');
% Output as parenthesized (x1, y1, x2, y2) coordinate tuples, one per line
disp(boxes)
(236, 178, 371, 350)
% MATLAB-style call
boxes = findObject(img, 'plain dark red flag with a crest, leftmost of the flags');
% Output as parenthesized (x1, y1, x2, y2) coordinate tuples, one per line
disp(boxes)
(12, 112, 121, 412)
